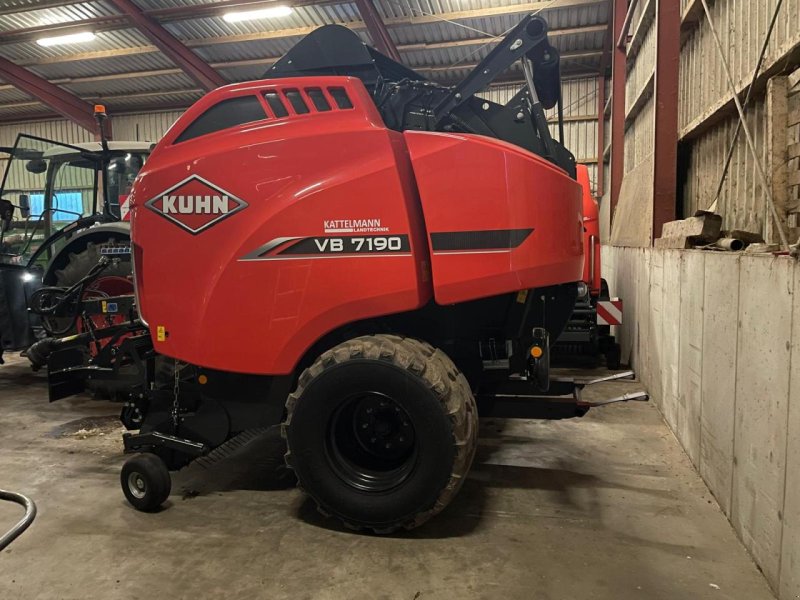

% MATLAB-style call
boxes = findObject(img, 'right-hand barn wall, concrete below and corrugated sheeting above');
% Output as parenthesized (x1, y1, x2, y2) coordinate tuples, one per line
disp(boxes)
(603, 0, 800, 600)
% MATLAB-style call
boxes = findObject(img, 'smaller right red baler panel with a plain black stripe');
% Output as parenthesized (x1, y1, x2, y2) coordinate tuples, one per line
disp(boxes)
(405, 132, 583, 304)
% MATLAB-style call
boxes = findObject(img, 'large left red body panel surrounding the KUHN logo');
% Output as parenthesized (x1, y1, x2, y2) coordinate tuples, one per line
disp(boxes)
(131, 78, 430, 374)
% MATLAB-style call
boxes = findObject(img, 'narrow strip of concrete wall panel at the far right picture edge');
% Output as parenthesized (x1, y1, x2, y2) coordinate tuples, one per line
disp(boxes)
(778, 263, 800, 600)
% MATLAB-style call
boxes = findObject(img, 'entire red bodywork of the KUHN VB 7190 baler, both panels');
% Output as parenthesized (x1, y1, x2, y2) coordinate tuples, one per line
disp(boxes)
(130, 77, 583, 375)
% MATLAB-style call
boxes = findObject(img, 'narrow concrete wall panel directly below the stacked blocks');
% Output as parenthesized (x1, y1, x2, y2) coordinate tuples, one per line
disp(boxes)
(677, 252, 706, 466)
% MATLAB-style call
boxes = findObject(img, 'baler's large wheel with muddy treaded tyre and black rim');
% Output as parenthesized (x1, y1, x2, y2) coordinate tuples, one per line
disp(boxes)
(283, 335, 478, 533)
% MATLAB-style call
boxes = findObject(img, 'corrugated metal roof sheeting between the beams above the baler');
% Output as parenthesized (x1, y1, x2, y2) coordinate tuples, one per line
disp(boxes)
(0, 0, 608, 119)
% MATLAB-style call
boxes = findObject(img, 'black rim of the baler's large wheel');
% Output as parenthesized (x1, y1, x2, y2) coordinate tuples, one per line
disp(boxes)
(327, 392, 417, 492)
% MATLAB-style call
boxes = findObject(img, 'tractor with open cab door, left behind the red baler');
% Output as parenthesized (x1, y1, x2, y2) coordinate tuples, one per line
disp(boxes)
(0, 134, 151, 364)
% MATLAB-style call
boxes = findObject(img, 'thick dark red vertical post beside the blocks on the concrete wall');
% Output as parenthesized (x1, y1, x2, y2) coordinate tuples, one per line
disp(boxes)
(653, 0, 681, 239)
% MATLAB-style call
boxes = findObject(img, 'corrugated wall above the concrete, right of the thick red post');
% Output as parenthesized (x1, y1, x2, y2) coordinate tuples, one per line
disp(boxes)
(679, 0, 800, 238)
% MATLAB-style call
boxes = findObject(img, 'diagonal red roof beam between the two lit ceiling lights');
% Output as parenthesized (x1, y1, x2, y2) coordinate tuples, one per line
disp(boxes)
(110, 0, 228, 91)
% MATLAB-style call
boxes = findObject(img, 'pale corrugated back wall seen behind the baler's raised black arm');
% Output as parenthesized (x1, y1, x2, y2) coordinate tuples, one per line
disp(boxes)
(480, 77, 598, 194)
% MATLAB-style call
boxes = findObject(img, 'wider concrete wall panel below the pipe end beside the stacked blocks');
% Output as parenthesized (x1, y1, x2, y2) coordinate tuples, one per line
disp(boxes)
(700, 253, 740, 517)
